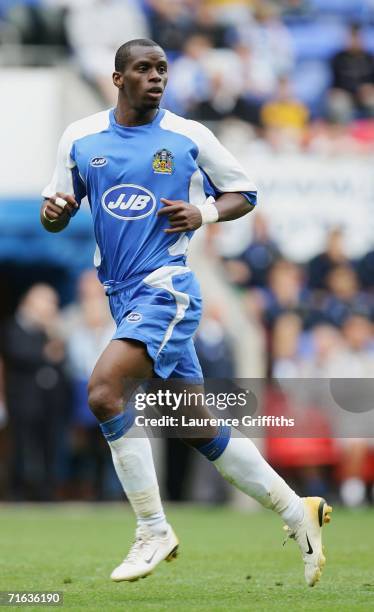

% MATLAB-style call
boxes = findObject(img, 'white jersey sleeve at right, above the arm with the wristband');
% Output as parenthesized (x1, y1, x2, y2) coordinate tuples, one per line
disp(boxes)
(191, 121, 257, 193)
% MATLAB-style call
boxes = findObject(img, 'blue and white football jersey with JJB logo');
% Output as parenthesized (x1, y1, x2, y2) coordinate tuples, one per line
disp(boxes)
(42, 109, 256, 288)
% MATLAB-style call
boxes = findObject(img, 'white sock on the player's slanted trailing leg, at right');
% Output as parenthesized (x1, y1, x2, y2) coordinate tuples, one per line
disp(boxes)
(213, 437, 304, 529)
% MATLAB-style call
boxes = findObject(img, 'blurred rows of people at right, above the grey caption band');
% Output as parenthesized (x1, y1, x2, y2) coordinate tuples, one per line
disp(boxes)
(222, 225, 374, 378)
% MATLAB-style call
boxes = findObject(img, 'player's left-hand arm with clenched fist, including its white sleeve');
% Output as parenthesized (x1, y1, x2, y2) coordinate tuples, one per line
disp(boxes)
(40, 124, 86, 233)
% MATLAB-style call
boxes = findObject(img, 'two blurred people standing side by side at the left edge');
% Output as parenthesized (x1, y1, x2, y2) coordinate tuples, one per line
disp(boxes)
(0, 271, 113, 500)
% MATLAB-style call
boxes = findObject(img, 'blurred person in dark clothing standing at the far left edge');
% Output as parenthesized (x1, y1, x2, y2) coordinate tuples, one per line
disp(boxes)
(0, 284, 70, 501)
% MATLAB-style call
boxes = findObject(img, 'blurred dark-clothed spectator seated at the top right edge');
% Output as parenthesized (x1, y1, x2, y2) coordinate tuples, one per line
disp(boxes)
(329, 24, 374, 122)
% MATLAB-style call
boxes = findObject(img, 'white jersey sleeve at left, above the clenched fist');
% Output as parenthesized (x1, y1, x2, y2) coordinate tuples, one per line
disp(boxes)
(42, 127, 76, 198)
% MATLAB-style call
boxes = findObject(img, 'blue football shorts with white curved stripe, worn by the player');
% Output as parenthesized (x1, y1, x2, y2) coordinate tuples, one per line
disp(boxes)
(109, 266, 203, 383)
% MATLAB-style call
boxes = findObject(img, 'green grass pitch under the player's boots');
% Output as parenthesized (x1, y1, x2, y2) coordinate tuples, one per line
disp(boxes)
(0, 505, 374, 612)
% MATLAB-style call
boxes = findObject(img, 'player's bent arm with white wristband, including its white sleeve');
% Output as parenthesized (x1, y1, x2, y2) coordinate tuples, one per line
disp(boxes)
(158, 121, 257, 234)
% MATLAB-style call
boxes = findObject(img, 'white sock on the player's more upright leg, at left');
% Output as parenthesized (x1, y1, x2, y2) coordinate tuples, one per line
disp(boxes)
(109, 428, 168, 533)
